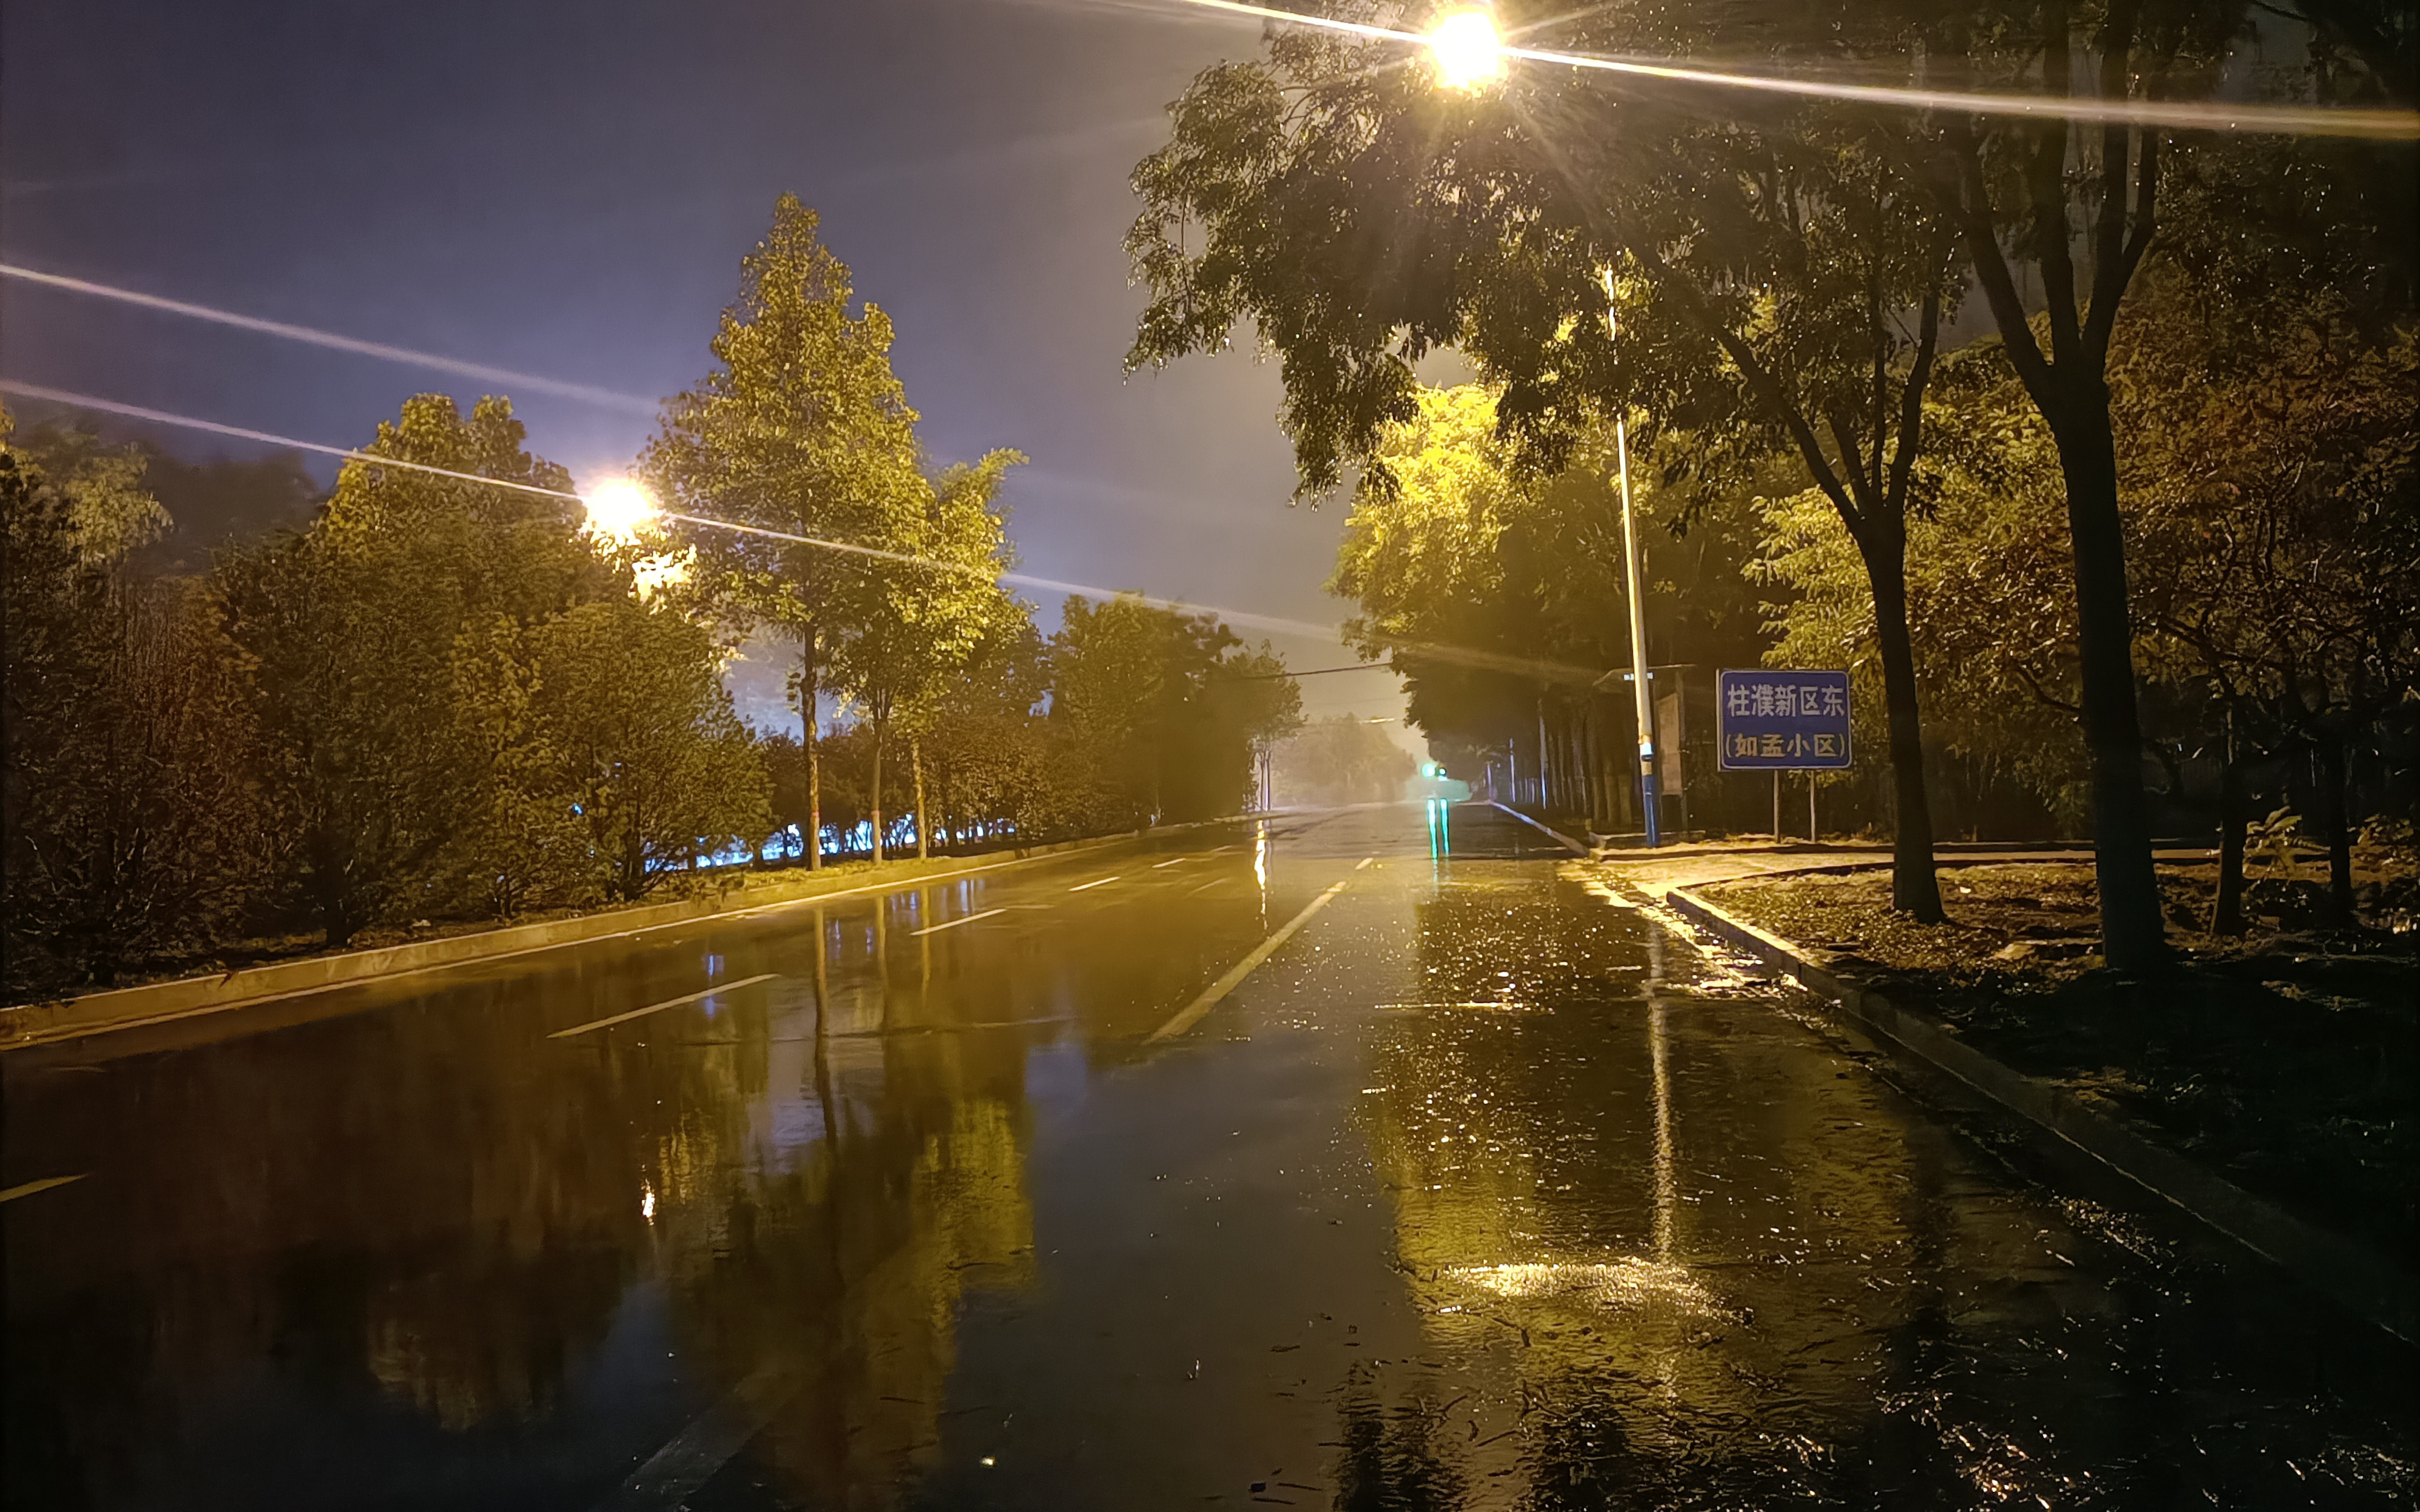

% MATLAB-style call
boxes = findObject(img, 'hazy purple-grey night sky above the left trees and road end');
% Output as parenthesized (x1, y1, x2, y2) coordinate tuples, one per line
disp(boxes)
(0, 0, 1411, 745)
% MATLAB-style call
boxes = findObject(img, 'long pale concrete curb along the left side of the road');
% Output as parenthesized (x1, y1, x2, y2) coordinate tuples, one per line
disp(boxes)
(0, 815, 1256, 1052)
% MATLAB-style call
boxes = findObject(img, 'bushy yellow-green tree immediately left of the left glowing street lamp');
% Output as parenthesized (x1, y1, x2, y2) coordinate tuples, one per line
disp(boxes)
(218, 394, 605, 946)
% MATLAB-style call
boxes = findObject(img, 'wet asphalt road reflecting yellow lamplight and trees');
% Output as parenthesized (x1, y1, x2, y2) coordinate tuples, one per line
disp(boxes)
(0, 806, 2415, 1512)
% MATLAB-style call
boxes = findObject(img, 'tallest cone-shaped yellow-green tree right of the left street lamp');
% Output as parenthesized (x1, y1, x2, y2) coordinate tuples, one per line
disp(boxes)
(641, 194, 925, 866)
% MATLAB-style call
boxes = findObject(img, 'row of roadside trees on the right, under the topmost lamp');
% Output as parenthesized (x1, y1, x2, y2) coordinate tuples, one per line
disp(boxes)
(1128, 0, 2415, 968)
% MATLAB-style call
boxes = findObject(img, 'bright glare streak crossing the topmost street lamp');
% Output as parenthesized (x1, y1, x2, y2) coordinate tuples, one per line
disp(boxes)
(1179, 0, 2420, 140)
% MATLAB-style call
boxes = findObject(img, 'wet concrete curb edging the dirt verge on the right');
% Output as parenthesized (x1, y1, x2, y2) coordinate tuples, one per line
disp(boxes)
(1665, 888, 2420, 1342)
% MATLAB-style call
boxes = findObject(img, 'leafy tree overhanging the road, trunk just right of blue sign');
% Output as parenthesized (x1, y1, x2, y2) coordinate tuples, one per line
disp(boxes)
(1128, 17, 1955, 919)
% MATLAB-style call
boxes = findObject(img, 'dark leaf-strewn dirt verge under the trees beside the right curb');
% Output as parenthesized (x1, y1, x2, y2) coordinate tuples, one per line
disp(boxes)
(1701, 864, 2420, 1270)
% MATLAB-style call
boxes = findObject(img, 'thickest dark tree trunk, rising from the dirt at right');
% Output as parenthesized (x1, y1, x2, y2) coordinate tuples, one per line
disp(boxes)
(2042, 394, 2168, 972)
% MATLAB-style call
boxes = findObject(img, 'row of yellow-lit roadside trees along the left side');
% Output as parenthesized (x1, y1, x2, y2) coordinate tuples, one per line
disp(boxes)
(0, 198, 1300, 997)
